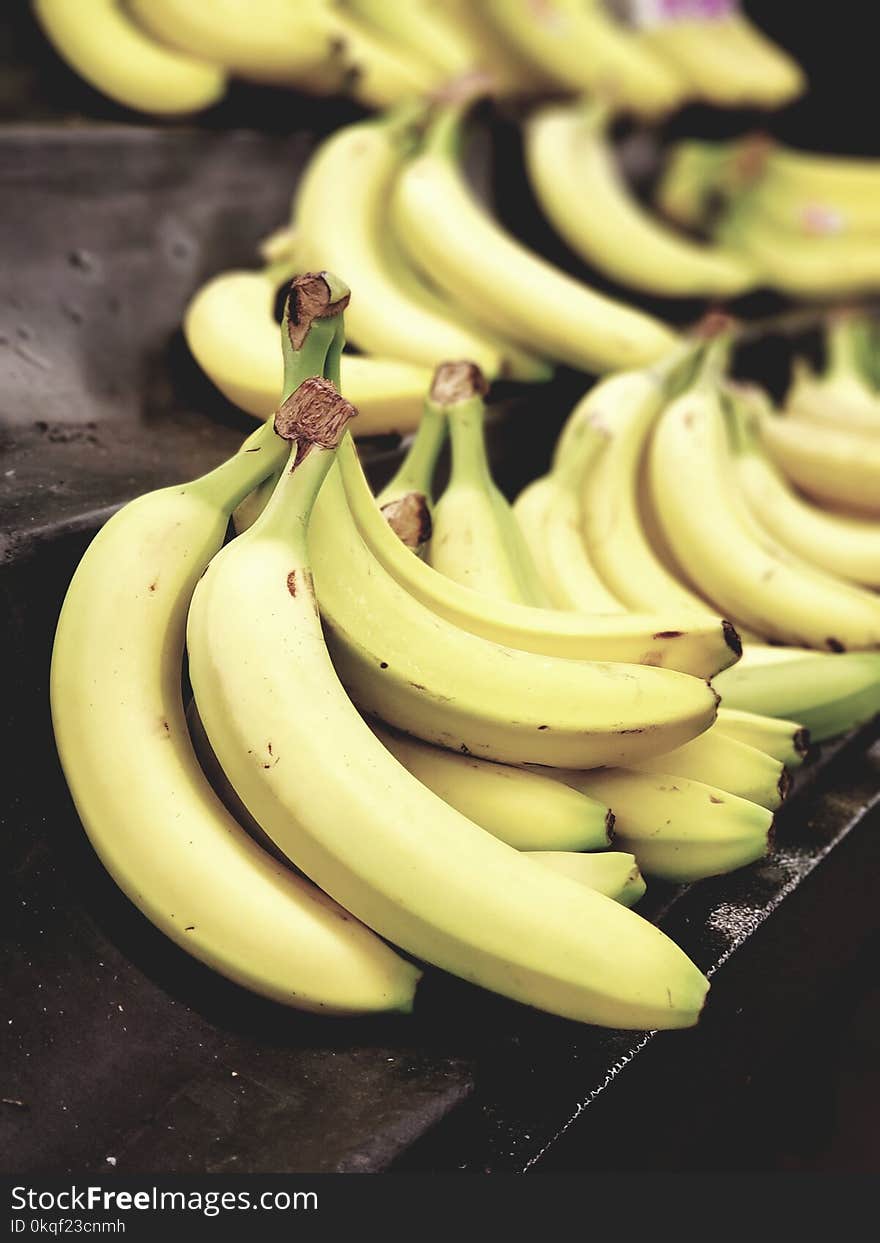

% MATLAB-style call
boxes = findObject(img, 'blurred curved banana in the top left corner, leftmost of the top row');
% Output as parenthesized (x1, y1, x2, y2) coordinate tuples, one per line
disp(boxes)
(32, 0, 226, 116)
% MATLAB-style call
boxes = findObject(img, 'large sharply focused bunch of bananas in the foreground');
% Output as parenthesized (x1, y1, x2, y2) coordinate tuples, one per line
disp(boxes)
(51, 272, 760, 1028)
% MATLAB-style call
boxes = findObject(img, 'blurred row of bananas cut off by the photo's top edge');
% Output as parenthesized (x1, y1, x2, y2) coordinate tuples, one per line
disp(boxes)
(34, 0, 804, 116)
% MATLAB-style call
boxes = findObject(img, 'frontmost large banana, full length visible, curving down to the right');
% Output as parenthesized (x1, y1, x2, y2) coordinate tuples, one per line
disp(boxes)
(188, 368, 707, 1029)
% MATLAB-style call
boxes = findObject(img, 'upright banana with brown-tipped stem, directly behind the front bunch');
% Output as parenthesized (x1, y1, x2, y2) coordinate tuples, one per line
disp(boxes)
(428, 363, 544, 604)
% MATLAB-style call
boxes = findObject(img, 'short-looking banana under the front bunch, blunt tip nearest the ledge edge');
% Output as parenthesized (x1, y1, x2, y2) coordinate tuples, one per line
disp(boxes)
(557, 768, 773, 883)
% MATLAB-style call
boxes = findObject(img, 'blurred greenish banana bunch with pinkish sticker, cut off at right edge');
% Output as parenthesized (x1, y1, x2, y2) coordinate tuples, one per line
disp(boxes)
(658, 135, 880, 298)
